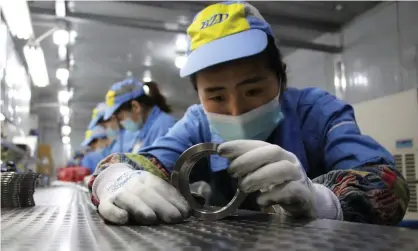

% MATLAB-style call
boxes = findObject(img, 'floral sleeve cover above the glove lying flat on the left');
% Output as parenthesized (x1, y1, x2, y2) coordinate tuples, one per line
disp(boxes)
(88, 153, 169, 206)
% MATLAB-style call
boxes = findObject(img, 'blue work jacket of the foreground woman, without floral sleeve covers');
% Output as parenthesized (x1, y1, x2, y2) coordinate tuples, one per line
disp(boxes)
(141, 88, 394, 179)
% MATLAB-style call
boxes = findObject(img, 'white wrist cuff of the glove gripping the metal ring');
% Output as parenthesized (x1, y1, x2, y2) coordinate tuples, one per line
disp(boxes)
(313, 183, 343, 220)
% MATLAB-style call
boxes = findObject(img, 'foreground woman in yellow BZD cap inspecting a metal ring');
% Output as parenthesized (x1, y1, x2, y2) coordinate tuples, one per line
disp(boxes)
(89, 2, 409, 225)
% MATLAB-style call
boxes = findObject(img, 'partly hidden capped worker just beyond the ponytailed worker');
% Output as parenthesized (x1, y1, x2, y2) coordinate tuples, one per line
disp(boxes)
(88, 102, 127, 154)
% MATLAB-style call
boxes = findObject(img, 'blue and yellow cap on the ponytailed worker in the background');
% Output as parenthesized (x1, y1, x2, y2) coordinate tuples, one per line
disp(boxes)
(103, 78, 147, 120)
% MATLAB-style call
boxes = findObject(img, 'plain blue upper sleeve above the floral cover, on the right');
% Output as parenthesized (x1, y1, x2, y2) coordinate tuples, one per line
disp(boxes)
(301, 88, 394, 171)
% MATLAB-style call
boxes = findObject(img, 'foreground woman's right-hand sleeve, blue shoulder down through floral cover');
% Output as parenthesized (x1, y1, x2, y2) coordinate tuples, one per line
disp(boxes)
(299, 88, 409, 225)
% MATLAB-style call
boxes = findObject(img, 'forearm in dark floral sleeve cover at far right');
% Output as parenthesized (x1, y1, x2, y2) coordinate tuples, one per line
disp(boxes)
(313, 165, 409, 225)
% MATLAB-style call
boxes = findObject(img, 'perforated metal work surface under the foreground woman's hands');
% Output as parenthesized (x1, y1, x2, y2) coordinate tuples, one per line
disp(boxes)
(1, 185, 418, 251)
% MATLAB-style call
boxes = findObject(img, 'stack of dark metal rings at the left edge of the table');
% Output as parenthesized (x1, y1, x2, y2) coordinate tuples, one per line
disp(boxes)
(1, 172, 39, 208)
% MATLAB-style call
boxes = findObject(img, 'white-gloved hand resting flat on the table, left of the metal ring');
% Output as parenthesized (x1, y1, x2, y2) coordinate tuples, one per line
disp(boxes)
(98, 163, 189, 224)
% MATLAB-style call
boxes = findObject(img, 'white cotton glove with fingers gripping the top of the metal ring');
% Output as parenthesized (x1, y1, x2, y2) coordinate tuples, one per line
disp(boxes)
(218, 140, 342, 219)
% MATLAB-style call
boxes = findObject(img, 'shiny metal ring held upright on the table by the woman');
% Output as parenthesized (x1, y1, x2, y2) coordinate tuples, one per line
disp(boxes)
(171, 143, 246, 220)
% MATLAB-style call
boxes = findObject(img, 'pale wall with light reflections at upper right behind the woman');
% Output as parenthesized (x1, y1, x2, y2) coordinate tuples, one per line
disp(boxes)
(285, 2, 418, 103)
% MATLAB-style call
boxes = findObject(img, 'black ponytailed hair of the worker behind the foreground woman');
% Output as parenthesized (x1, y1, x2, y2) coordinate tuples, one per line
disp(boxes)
(115, 81, 172, 113)
